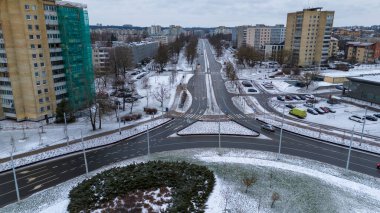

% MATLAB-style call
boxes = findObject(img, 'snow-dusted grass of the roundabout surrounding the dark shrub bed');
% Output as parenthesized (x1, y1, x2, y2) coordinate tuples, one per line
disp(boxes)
(0, 149, 380, 213)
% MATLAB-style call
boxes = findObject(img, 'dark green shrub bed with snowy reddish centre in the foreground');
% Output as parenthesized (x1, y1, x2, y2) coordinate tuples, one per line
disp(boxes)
(68, 161, 215, 212)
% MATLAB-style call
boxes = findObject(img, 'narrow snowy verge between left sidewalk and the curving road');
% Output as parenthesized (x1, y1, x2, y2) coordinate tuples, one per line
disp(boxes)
(0, 118, 170, 172)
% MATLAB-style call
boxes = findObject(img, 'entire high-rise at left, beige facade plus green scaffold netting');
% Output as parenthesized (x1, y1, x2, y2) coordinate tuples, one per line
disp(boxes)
(0, 0, 94, 121)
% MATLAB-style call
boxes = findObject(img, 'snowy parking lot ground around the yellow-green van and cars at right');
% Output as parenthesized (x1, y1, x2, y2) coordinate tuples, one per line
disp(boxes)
(270, 98, 380, 136)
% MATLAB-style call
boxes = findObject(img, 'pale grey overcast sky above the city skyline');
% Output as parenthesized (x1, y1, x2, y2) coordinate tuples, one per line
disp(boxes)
(71, 0, 380, 27)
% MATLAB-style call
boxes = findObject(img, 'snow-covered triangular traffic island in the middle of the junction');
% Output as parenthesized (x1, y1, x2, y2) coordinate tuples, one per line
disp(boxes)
(177, 121, 259, 136)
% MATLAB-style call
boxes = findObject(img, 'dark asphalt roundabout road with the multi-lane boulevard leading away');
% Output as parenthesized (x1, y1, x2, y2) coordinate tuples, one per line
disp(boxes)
(0, 40, 380, 206)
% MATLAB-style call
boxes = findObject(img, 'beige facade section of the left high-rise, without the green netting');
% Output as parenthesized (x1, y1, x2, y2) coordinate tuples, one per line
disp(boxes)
(0, 0, 56, 121)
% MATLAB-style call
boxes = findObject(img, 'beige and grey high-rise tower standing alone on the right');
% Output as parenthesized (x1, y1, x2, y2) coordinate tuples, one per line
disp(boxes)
(285, 7, 335, 67)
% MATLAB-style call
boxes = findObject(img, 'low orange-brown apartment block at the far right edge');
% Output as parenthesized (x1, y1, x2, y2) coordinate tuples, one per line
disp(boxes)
(346, 42, 380, 63)
